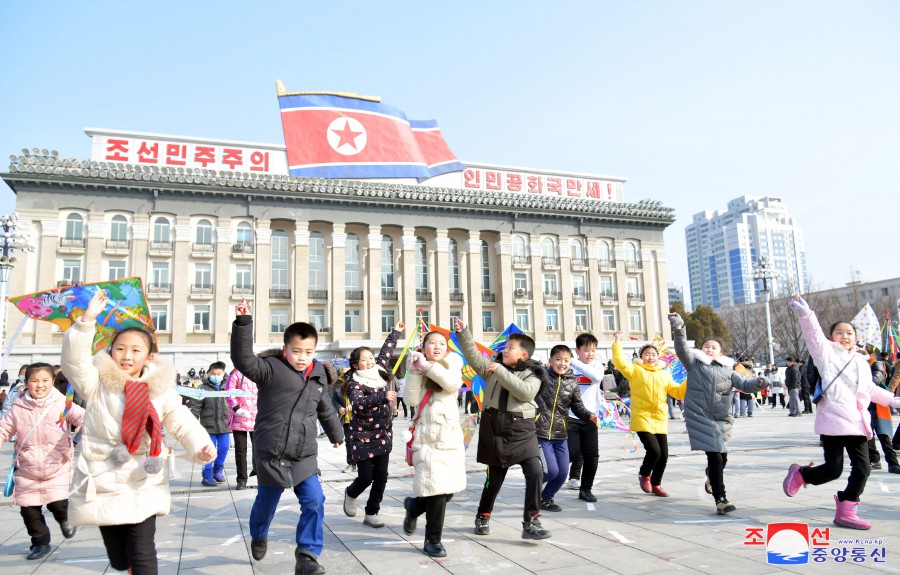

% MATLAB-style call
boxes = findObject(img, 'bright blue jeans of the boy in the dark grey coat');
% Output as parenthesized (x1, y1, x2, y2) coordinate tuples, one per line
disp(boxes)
(250, 475, 325, 557)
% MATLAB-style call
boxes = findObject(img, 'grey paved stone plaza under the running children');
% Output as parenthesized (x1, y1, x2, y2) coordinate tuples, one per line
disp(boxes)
(0, 408, 900, 575)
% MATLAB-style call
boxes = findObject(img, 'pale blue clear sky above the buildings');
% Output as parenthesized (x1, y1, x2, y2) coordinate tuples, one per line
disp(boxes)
(0, 0, 900, 306)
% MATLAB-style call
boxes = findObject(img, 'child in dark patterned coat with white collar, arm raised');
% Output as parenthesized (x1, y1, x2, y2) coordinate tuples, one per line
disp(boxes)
(343, 323, 404, 528)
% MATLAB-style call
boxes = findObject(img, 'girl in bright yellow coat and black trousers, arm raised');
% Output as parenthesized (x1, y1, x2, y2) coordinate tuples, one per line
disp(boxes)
(613, 331, 681, 497)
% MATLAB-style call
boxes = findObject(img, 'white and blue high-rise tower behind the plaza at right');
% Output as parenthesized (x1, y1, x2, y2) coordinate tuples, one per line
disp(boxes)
(685, 196, 809, 308)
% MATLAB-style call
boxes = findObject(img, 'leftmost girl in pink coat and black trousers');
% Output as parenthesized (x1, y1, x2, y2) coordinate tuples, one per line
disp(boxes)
(0, 363, 84, 559)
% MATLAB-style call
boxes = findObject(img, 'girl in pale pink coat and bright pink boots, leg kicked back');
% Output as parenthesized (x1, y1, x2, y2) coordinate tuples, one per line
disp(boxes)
(784, 295, 900, 529)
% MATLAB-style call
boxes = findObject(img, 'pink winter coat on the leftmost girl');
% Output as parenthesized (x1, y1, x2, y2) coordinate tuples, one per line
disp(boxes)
(0, 389, 84, 507)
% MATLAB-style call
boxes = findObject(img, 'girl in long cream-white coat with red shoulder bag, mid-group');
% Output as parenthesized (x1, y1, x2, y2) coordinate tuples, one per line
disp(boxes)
(403, 332, 466, 557)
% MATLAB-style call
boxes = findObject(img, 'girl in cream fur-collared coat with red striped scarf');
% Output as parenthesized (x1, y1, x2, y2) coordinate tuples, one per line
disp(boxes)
(61, 290, 216, 575)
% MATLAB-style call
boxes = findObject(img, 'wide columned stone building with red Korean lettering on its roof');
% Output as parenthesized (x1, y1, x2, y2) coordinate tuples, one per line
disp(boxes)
(2, 129, 674, 370)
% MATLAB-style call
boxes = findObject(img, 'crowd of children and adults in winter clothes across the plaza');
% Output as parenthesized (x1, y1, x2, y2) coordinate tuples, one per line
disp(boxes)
(0, 292, 900, 575)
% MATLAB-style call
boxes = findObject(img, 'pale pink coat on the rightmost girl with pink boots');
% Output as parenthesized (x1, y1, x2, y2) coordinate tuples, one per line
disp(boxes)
(799, 312, 893, 439)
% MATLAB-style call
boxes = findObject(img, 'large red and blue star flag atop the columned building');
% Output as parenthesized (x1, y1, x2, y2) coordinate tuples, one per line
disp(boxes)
(278, 83, 464, 180)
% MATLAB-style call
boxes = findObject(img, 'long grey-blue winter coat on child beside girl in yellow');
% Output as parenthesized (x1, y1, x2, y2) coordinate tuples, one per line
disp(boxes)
(671, 324, 769, 453)
